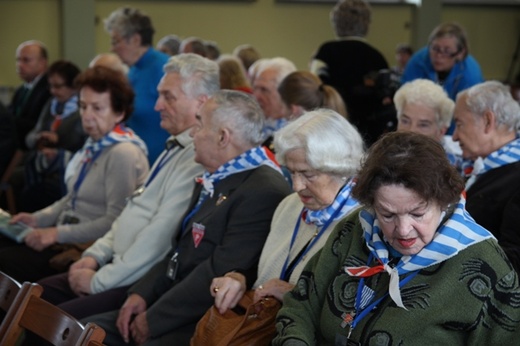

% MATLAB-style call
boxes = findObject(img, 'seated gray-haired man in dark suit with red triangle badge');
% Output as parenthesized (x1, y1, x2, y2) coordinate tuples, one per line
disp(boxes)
(85, 91, 290, 345)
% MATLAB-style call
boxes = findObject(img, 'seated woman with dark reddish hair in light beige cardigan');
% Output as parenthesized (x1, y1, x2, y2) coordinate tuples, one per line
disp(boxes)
(0, 66, 149, 281)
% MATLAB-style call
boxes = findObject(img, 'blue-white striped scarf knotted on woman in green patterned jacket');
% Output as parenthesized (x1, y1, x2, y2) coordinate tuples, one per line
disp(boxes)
(345, 196, 493, 309)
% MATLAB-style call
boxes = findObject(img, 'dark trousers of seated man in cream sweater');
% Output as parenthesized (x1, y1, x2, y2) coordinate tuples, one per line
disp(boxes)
(38, 273, 130, 319)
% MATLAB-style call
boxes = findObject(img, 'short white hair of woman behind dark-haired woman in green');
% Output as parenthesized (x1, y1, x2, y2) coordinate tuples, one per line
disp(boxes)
(394, 79, 455, 128)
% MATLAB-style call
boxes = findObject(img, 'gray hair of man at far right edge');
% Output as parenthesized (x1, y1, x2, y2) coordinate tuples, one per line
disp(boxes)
(457, 81, 520, 131)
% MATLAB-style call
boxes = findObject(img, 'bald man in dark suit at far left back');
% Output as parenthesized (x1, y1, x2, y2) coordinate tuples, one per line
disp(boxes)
(9, 41, 51, 150)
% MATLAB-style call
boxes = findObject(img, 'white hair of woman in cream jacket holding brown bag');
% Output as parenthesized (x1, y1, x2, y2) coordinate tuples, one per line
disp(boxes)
(274, 108, 365, 177)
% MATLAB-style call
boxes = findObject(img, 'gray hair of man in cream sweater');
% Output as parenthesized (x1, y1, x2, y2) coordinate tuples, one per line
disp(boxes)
(164, 53, 220, 98)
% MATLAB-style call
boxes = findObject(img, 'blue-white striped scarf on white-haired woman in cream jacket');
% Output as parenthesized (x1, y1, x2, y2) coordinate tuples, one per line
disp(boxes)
(303, 178, 359, 227)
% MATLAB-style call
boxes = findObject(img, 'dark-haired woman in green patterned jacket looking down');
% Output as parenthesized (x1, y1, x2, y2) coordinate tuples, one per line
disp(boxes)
(273, 132, 520, 345)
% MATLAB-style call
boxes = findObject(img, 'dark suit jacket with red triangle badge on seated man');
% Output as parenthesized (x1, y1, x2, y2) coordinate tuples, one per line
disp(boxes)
(130, 166, 291, 345)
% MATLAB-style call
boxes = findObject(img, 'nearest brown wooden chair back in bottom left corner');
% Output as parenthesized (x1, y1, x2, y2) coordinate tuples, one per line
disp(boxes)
(0, 285, 105, 346)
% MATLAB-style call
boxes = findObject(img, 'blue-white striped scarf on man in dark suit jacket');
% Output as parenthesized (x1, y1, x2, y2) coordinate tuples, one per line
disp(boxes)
(197, 147, 283, 197)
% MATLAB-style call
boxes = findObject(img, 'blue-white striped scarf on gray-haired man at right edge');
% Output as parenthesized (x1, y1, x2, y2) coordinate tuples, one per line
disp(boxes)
(466, 138, 520, 190)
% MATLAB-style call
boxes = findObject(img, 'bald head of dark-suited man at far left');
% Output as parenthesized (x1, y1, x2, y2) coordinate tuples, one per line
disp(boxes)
(16, 41, 47, 83)
